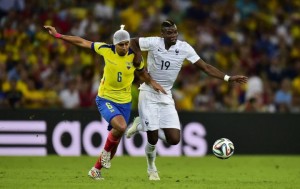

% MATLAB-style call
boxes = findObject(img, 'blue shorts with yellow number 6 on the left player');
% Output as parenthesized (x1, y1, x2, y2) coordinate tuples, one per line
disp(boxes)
(96, 96, 131, 131)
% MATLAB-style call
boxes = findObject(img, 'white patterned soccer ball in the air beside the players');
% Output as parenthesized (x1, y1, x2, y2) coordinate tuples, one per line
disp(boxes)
(212, 138, 234, 159)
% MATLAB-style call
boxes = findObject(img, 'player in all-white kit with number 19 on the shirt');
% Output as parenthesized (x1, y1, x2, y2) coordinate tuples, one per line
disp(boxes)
(126, 20, 247, 180)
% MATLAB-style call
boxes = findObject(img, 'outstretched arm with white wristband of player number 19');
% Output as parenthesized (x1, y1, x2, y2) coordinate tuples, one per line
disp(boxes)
(195, 59, 248, 84)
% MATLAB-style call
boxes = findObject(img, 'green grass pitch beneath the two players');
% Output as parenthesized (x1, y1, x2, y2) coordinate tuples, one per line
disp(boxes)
(0, 155, 300, 189)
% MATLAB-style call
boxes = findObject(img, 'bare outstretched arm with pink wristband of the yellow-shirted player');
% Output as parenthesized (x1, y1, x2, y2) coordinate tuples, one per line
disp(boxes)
(44, 26, 92, 48)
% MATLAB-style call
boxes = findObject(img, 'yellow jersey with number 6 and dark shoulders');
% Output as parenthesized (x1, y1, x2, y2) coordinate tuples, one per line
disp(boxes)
(91, 42, 144, 104)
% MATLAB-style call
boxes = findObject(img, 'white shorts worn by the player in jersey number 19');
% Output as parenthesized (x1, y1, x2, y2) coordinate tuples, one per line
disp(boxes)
(139, 90, 180, 131)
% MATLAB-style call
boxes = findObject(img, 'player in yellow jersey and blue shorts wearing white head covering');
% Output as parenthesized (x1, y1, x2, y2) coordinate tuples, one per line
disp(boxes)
(44, 25, 166, 180)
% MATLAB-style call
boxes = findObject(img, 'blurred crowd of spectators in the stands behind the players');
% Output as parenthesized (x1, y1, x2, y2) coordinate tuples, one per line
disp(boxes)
(0, 0, 300, 112)
